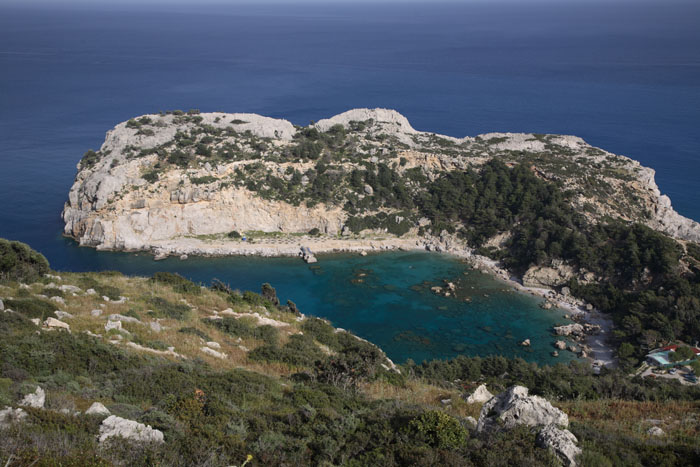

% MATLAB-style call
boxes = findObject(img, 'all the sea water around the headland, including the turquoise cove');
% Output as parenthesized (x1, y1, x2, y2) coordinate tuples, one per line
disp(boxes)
(0, 1, 700, 363)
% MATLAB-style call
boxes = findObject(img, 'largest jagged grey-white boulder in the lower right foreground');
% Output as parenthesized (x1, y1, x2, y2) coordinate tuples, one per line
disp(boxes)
(477, 386, 569, 432)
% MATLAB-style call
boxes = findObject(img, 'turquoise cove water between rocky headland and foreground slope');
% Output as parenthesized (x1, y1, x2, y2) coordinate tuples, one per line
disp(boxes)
(52, 241, 572, 364)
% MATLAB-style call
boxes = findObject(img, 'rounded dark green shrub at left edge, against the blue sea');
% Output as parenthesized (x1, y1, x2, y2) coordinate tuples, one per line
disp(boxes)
(0, 238, 49, 282)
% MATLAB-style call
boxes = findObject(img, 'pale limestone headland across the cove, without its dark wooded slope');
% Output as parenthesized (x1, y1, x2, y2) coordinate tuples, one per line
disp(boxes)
(63, 109, 700, 254)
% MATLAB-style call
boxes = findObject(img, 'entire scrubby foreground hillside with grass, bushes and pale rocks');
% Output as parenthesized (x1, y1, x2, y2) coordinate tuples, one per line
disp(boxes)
(0, 240, 700, 466)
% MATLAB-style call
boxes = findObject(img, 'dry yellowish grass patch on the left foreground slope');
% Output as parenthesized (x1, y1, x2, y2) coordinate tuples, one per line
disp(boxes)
(2, 273, 306, 380)
